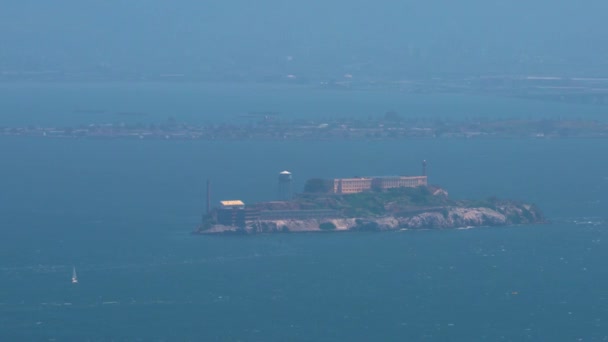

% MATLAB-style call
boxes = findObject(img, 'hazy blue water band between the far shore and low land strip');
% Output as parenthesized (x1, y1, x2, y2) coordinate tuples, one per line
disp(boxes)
(0, 82, 606, 127)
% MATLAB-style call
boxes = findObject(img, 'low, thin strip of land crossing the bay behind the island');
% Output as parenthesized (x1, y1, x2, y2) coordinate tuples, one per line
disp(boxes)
(0, 117, 608, 140)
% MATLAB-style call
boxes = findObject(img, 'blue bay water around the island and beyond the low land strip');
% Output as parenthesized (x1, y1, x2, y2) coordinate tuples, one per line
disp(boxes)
(0, 85, 608, 341)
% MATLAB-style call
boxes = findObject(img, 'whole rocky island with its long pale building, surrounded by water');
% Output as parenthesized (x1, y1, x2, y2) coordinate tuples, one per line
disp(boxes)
(194, 171, 545, 234)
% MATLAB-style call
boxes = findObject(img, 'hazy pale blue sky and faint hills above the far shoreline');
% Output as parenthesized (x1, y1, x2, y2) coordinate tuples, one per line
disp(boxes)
(0, 0, 608, 77)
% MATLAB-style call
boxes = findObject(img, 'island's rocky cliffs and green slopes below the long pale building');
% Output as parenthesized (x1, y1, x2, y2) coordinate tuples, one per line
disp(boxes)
(196, 186, 545, 234)
